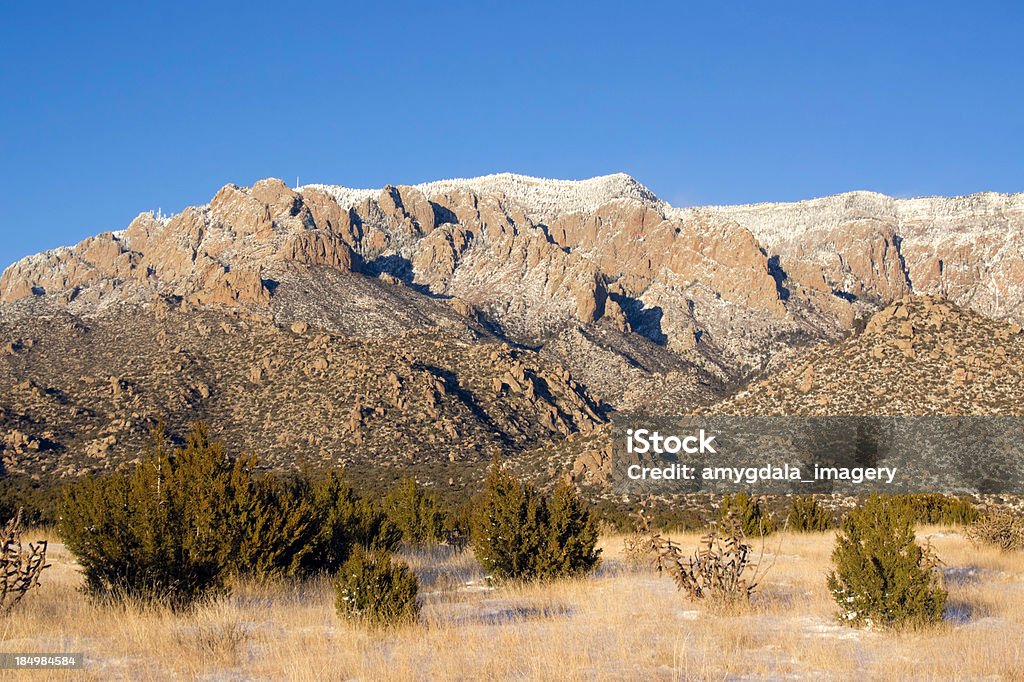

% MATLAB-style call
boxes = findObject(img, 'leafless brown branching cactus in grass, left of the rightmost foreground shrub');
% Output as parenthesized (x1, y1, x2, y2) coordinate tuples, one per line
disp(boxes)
(640, 509, 771, 606)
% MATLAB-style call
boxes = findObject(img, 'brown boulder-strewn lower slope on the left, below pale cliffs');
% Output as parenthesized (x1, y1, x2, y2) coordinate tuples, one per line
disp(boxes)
(0, 292, 603, 484)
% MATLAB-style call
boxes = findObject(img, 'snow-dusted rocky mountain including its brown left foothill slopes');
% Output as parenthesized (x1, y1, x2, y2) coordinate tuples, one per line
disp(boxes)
(0, 173, 1024, 478)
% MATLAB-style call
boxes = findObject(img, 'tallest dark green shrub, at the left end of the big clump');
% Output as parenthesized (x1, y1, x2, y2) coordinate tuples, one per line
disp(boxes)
(58, 425, 241, 606)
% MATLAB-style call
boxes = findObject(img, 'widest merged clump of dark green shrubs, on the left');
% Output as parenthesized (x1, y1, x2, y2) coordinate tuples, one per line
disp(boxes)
(58, 425, 400, 593)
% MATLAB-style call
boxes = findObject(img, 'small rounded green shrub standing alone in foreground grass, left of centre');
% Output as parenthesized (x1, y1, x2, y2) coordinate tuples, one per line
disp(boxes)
(335, 548, 420, 628)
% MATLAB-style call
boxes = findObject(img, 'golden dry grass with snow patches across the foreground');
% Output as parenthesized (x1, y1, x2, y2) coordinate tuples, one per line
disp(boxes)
(0, 528, 1024, 681)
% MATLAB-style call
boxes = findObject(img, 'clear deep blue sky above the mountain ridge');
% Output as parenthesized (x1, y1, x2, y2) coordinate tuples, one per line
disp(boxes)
(0, 0, 1024, 267)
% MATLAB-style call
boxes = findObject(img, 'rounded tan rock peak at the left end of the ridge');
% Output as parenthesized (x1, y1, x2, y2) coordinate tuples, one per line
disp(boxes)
(0, 180, 354, 309)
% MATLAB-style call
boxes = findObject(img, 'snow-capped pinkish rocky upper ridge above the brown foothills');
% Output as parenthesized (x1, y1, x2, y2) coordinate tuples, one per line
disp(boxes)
(0, 174, 1024, 407)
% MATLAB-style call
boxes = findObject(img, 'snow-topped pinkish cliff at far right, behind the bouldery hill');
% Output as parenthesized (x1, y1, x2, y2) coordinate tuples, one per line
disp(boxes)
(700, 191, 1024, 322)
